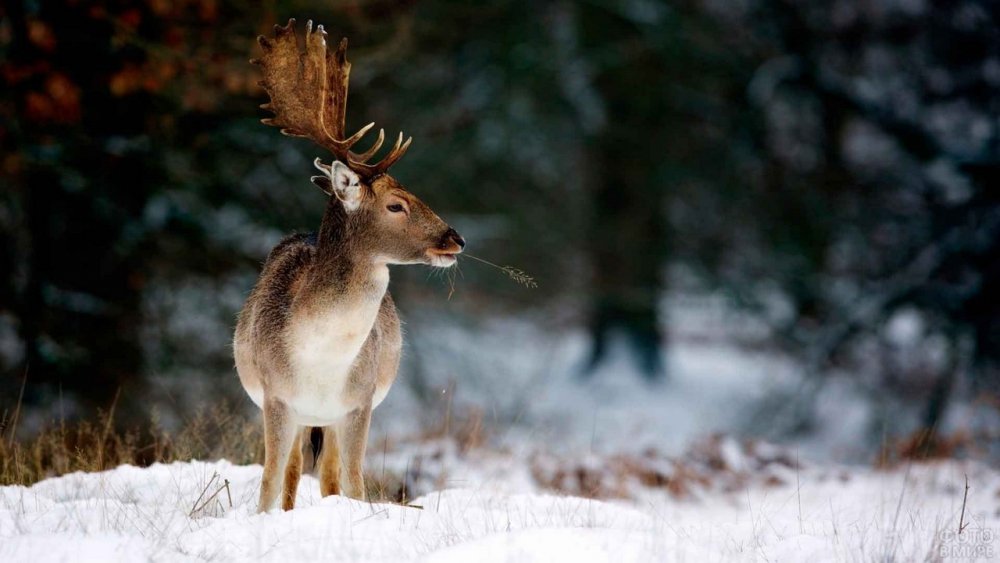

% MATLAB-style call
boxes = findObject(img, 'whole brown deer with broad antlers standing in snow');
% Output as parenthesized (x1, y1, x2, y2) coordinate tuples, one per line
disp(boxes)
(233, 19, 465, 512)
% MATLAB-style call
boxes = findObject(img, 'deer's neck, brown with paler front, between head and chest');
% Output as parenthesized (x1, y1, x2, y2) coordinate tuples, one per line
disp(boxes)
(309, 198, 389, 303)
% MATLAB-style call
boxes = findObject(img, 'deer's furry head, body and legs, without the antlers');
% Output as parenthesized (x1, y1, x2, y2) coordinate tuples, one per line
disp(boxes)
(234, 175, 464, 511)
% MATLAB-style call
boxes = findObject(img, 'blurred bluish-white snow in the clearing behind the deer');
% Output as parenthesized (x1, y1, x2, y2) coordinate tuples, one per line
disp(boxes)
(384, 307, 804, 460)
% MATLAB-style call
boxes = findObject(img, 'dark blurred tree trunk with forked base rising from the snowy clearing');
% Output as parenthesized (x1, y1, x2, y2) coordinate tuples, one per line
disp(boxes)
(576, 3, 678, 379)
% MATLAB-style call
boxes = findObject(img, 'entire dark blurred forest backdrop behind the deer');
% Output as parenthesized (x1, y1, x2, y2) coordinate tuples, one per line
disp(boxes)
(0, 0, 1000, 446)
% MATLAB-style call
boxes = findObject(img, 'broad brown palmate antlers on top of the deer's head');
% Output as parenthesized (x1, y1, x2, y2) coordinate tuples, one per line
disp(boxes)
(250, 18, 413, 179)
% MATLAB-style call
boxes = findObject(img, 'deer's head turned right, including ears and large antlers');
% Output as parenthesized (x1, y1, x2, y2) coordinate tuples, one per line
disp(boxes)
(251, 19, 465, 267)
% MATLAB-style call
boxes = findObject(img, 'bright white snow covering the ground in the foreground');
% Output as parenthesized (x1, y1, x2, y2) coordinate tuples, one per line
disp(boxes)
(0, 456, 1000, 563)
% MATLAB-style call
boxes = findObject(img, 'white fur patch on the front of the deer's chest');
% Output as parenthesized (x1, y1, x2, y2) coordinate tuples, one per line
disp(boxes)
(285, 268, 389, 425)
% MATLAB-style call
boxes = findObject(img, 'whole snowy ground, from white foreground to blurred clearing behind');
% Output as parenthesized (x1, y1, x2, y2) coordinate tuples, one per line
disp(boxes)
(0, 312, 1000, 563)
